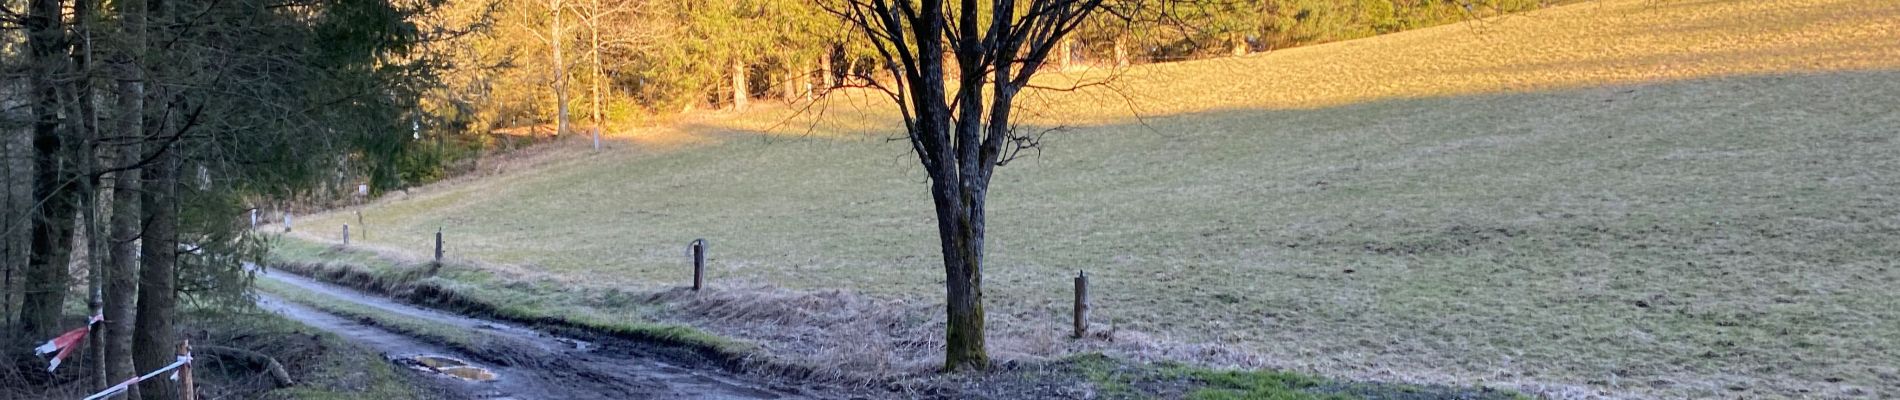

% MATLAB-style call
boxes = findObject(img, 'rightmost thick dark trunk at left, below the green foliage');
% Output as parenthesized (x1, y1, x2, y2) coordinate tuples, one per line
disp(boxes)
(133, 136, 179, 400)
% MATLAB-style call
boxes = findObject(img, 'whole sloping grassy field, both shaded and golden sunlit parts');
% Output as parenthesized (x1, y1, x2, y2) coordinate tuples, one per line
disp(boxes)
(281, 0, 1900, 398)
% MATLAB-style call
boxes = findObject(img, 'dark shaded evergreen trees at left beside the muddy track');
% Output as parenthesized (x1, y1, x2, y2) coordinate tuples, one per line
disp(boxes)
(0, 0, 448, 398)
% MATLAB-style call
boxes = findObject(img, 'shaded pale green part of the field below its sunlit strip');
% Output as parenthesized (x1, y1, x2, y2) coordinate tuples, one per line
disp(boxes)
(281, 70, 1900, 396)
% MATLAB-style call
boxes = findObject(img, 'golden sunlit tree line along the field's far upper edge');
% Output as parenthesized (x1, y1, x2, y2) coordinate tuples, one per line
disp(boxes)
(435, 0, 1564, 135)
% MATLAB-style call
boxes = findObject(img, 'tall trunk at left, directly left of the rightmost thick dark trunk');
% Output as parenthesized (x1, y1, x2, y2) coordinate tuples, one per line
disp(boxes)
(103, 0, 146, 386)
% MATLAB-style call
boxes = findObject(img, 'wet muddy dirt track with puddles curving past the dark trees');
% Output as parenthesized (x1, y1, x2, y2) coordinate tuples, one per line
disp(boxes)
(258, 271, 844, 400)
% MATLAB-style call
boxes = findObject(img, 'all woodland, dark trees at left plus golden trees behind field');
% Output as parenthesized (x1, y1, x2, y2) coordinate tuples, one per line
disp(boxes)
(0, 0, 1547, 398)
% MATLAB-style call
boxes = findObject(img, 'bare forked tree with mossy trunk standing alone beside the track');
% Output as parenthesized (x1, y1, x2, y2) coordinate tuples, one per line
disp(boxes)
(827, 0, 1104, 370)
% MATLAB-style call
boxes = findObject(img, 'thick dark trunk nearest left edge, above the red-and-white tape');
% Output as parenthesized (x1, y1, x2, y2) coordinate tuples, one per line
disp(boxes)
(21, 0, 78, 337)
